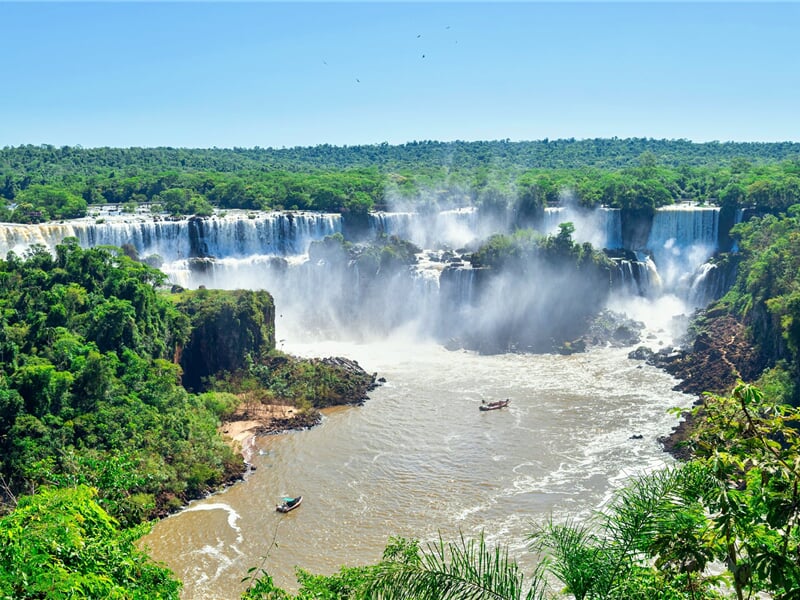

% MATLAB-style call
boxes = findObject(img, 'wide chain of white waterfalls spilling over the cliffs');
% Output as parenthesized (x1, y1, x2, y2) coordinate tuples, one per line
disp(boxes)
(0, 206, 732, 349)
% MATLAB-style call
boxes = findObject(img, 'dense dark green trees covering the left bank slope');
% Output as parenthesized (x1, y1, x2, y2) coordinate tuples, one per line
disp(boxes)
(0, 239, 242, 526)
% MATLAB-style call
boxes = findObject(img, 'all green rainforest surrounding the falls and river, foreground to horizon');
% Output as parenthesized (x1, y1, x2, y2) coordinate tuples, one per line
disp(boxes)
(0, 140, 800, 600)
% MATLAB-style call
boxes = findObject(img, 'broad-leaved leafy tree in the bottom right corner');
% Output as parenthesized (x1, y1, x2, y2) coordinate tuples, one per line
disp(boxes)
(692, 384, 800, 598)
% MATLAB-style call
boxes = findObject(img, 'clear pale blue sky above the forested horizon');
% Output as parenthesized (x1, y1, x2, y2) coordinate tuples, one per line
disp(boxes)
(0, 0, 800, 147)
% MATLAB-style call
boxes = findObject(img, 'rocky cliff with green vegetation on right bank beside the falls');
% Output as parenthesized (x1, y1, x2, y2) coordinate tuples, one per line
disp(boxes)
(656, 204, 800, 405)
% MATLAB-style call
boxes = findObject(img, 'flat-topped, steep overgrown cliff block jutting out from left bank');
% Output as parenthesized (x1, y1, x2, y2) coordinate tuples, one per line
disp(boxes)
(179, 289, 275, 391)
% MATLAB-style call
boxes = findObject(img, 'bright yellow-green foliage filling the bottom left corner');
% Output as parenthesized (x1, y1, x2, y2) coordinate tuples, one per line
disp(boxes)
(0, 486, 181, 600)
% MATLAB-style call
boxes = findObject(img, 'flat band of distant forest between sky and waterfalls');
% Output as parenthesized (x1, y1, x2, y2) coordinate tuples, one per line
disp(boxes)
(0, 139, 800, 223)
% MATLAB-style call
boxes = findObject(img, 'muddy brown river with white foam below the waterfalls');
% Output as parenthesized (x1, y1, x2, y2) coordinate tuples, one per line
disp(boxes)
(142, 336, 692, 600)
